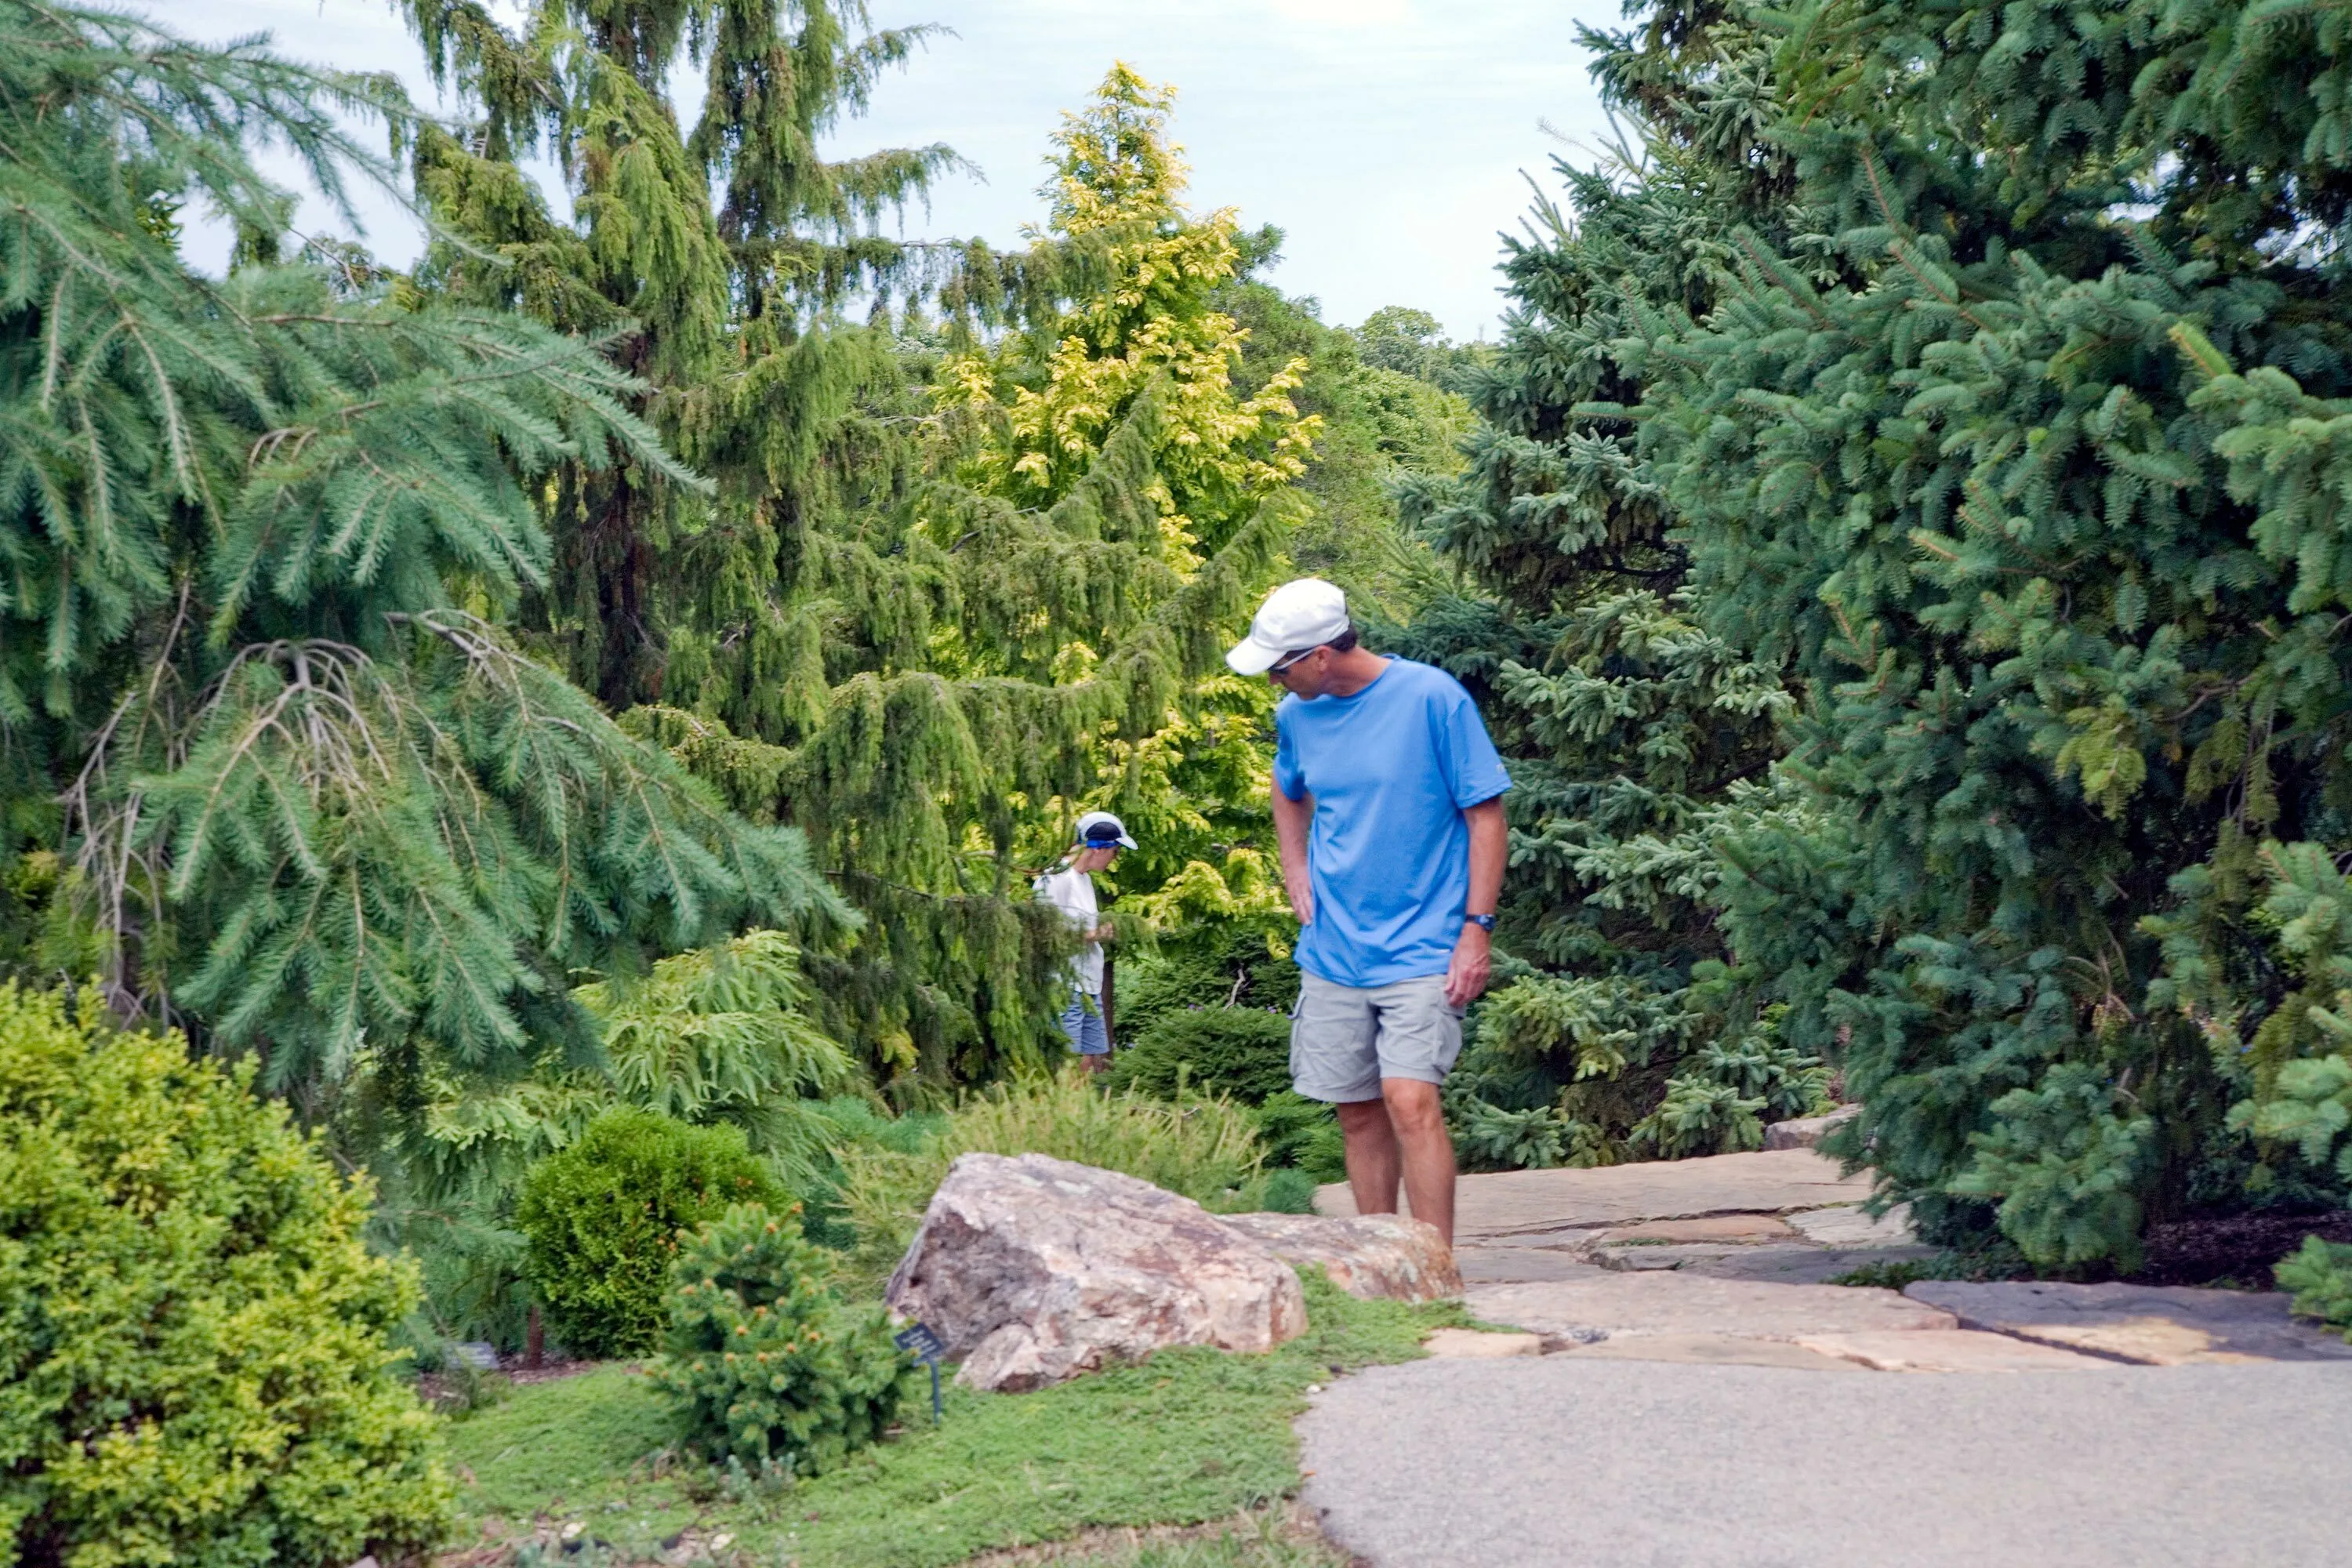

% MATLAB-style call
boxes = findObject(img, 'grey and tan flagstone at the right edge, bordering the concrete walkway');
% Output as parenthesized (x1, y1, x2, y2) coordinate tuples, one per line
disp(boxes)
(1903, 1279, 2352, 1366)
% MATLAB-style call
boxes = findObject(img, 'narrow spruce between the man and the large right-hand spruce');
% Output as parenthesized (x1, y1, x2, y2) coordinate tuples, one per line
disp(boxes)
(1367, 5, 1820, 1166)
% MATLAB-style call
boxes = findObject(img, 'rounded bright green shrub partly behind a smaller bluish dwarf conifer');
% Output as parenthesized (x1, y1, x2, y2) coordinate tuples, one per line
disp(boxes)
(515, 1109, 790, 1356)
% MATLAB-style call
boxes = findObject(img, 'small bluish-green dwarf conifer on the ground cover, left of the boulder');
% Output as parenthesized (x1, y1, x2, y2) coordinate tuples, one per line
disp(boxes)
(654, 1203, 910, 1474)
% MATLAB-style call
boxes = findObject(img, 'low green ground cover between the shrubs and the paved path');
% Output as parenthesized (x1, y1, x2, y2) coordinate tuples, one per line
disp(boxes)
(449, 1272, 1468, 1568)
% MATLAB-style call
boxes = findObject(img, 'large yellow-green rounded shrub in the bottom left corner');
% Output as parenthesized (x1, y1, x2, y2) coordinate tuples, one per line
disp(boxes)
(0, 985, 449, 1568)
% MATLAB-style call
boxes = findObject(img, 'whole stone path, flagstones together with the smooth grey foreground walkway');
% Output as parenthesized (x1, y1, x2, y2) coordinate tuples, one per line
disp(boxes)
(1301, 1147, 2352, 1568)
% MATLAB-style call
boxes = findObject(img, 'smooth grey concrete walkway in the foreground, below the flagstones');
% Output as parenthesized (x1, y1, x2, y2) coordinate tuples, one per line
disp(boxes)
(1298, 1356, 2352, 1568)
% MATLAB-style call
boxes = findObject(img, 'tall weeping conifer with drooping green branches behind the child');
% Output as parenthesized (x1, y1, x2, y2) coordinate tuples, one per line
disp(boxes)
(393, 21, 1282, 1079)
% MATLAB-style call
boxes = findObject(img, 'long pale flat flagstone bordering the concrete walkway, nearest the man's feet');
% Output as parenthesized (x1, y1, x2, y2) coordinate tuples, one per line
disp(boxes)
(1465, 1269, 1959, 1340)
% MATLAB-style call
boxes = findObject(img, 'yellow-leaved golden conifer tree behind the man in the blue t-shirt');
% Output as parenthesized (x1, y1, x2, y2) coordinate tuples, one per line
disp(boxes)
(938, 64, 1322, 1006)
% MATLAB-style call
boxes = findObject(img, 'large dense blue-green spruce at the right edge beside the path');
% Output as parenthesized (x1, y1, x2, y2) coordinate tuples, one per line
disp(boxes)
(1611, 0, 2352, 1267)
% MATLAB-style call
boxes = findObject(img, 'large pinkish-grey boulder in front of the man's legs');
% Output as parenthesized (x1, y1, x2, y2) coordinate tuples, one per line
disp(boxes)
(887, 1154, 1308, 1389)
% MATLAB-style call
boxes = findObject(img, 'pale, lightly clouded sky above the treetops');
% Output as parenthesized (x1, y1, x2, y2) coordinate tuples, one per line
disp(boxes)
(156, 0, 1621, 339)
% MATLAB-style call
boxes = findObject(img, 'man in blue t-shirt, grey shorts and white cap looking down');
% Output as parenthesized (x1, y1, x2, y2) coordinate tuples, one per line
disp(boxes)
(1225, 579, 1510, 1243)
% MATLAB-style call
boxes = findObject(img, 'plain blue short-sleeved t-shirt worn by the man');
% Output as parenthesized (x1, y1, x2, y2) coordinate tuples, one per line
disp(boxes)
(1275, 659, 1510, 985)
